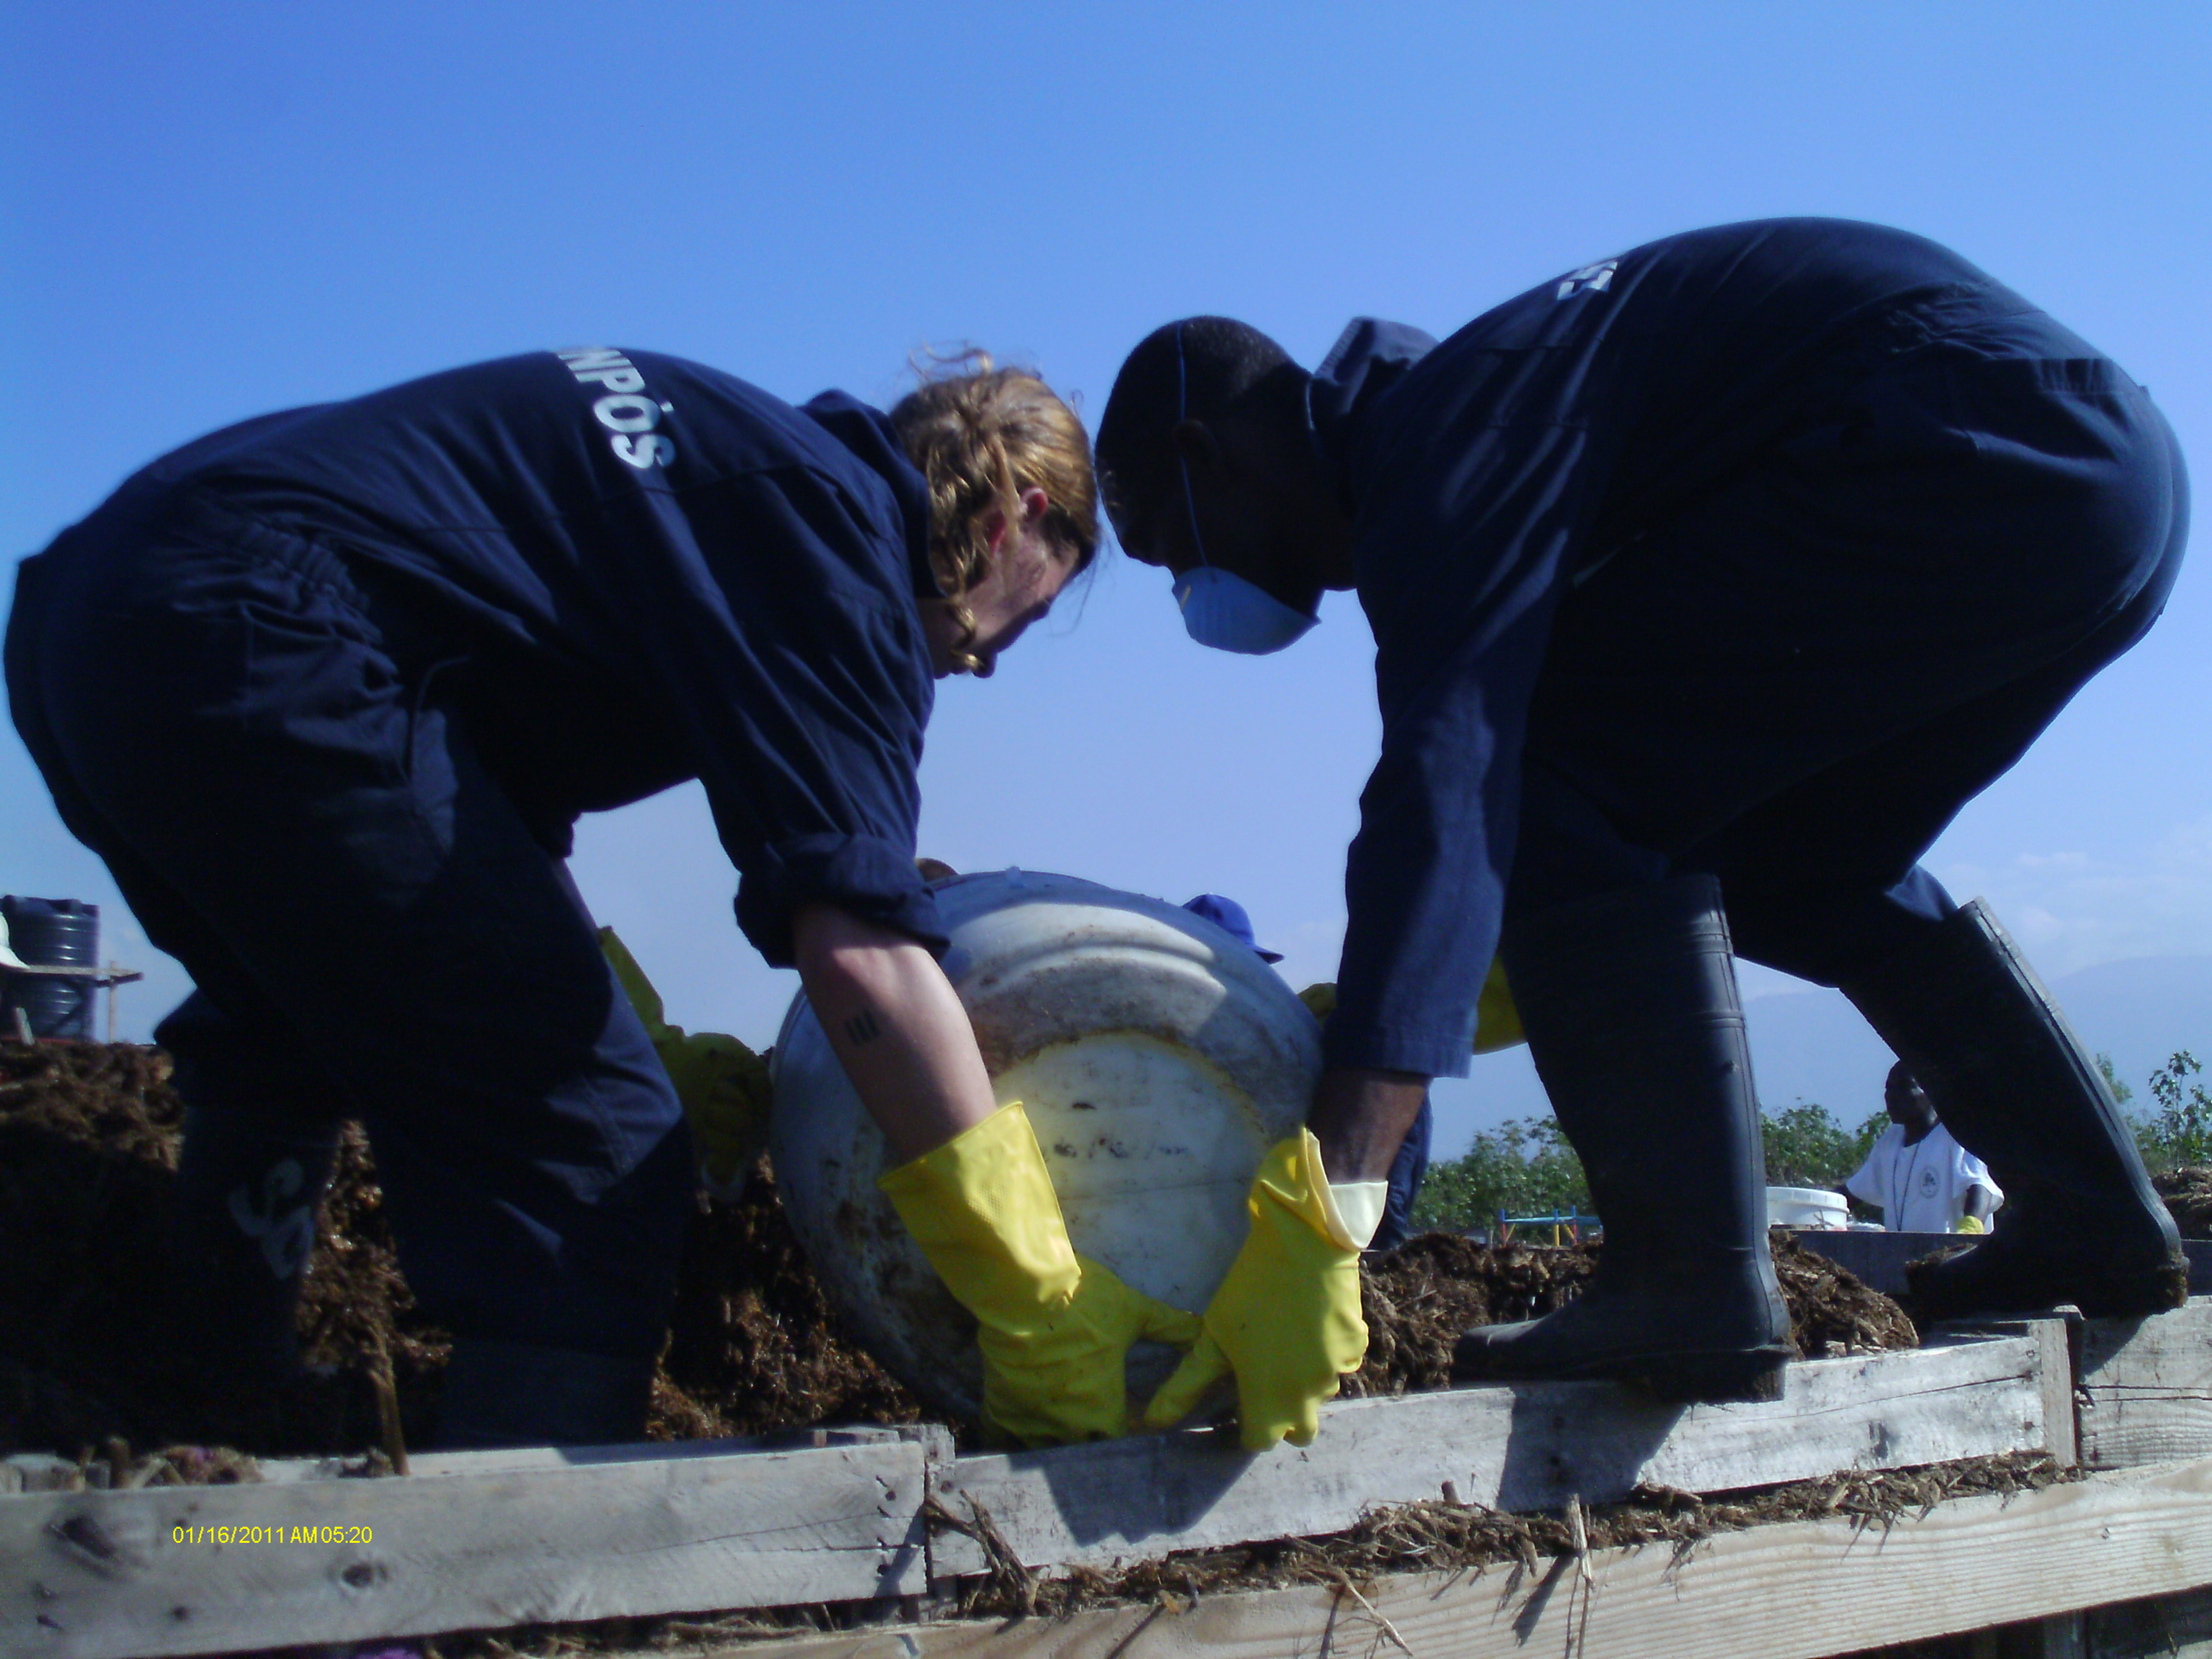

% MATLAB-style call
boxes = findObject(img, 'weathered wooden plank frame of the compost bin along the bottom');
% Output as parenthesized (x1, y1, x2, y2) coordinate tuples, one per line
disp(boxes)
(0, 1298, 2212, 1659)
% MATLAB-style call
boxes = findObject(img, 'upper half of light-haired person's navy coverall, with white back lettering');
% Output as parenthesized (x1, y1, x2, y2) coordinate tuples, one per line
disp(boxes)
(71, 350, 945, 967)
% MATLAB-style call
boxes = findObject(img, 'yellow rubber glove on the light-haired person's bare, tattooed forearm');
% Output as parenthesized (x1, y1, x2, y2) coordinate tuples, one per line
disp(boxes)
(878, 1101, 1201, 1447)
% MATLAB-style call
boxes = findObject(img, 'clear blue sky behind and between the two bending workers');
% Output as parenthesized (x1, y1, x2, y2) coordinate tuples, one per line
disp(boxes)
(0, 0, 2212, 1153)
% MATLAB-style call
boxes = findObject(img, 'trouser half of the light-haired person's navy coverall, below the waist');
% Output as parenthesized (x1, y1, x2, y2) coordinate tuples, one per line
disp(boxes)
(7, 493, 695, 1360)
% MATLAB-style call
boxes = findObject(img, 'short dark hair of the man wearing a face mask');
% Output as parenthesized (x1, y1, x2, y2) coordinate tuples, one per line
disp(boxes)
(1097, 316, 1305, 560)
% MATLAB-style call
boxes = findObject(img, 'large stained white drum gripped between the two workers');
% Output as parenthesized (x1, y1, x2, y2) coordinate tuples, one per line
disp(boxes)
(770, 869, 1320, 1416)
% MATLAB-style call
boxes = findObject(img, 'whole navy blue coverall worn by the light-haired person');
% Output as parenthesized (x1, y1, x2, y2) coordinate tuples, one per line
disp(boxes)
(7, 350, 945, 1416)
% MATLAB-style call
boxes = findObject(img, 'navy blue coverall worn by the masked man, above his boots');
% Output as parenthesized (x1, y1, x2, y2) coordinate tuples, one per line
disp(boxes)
(1307, 219, 2187, 1075)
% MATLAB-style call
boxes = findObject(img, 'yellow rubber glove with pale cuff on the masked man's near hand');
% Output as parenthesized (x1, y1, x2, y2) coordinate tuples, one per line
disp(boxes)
(1144, 1128, 1367, 1451)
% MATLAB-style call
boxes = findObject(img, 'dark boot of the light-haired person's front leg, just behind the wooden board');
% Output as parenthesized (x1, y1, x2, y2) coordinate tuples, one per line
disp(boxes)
(438, 1336, 653, 1451)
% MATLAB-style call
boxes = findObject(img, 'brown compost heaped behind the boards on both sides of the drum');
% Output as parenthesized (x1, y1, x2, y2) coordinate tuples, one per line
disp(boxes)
(0, 1044, 1915, 1467)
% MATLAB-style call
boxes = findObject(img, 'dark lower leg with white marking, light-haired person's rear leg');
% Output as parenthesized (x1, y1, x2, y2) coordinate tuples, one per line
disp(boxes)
(175, 1108, 339, 1389)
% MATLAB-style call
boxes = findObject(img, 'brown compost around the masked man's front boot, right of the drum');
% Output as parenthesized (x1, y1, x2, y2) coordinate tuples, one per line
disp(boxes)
(1345, 1232, 1920, 1394)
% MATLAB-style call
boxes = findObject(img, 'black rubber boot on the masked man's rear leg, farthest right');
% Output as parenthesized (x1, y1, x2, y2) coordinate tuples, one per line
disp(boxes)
(1843, 900, 2190, 1320)
